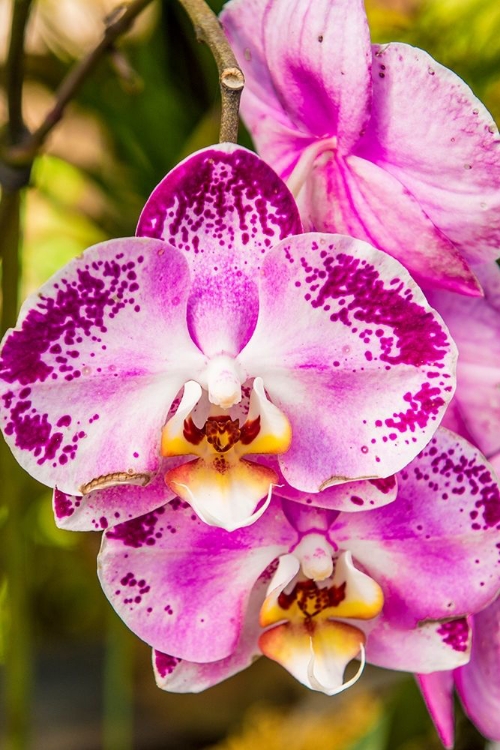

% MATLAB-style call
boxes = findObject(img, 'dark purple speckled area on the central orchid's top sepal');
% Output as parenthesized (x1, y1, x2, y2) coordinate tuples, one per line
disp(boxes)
(137, 144, 302, 272)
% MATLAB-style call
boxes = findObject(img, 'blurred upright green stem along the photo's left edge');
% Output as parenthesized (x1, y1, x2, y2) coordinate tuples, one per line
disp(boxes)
(0, 0, 32, 750)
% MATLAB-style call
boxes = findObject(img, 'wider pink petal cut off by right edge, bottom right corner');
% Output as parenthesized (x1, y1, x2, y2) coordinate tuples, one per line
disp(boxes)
(455, 599, 500, 740)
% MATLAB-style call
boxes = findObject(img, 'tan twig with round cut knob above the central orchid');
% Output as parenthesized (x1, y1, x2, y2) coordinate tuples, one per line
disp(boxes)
(179, 0, 245, 143)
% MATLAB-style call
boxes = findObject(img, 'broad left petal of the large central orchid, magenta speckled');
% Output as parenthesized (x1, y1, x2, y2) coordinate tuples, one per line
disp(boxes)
(0, 238, 205, 495)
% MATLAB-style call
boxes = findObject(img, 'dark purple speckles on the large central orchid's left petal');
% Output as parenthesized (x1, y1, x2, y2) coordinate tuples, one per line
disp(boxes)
(0, 241, 145, 466)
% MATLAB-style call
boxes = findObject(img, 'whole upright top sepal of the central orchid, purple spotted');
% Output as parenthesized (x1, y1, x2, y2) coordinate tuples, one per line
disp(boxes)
(137, 143, 301, 356)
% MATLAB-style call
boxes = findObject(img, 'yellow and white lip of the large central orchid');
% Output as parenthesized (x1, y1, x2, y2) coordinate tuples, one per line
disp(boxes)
(161, 378, 291, 531)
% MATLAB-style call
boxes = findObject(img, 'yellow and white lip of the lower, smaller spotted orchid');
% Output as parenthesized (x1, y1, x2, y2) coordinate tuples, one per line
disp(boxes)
(259, 548, 383, 695)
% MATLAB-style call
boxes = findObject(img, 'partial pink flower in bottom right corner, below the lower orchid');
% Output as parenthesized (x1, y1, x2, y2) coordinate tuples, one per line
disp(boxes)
(417, 453, 500, 748)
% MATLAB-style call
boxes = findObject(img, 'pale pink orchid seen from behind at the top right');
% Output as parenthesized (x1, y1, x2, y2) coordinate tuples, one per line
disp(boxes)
(221, 0, 500, 296)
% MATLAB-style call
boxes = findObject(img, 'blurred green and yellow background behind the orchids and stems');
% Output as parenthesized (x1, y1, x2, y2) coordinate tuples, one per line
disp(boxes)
(0, 0, 500, 750)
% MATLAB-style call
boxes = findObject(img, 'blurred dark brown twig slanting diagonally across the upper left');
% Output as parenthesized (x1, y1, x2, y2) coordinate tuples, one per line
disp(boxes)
(4, 0, 153, 166)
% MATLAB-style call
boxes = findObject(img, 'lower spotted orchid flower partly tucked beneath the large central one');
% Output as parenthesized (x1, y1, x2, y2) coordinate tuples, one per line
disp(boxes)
(99, 429, 500, 695)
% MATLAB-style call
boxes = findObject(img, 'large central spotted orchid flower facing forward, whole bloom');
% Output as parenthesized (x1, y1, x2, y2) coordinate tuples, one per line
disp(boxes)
(0, 144, 456, 530)
